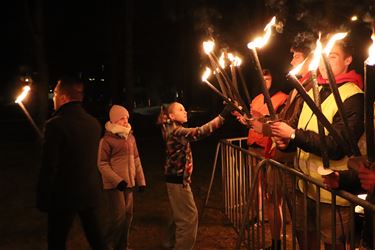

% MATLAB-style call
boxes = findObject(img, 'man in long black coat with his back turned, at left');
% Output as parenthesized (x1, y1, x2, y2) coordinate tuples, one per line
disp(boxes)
(37, 77, 106, 250)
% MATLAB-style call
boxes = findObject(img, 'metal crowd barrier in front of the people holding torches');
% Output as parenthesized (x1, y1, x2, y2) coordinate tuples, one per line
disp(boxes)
(201, 138, 375, 249)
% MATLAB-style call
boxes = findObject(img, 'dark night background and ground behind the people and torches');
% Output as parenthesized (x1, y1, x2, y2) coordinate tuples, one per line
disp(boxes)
(0, 0, 375, 250)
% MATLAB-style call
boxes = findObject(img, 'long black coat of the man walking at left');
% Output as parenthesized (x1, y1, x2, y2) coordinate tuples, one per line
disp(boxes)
(37, 102, 102, 211)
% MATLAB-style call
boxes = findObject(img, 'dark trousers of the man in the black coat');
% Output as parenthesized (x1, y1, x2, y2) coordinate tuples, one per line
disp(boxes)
(48, 208, 107, 250)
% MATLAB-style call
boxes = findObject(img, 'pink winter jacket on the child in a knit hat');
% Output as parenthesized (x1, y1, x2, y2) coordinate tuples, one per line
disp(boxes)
(98, 131, 146, 189)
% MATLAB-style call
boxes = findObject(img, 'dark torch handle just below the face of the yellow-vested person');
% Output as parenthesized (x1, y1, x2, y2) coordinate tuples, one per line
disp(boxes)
(322, 53, 361, 156)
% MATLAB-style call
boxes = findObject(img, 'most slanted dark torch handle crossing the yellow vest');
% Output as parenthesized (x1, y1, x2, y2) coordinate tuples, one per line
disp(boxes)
(287, 74, 351, 156)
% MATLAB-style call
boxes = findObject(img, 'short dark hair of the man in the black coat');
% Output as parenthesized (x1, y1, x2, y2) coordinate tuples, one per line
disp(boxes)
(57, 76, 84, 101)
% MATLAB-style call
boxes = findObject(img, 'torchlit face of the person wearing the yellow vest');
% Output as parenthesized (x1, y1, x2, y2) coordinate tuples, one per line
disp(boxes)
(319, 45, 352, 79)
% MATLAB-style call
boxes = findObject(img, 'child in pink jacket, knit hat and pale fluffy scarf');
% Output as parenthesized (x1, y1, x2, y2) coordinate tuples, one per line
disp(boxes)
(98, 105, 146, 250)
